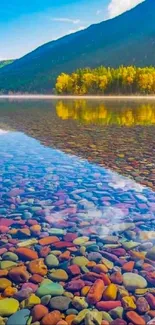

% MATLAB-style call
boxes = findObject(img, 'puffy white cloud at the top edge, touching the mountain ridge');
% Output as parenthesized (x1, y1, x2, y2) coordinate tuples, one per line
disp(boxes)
(107, 0, 144, 18)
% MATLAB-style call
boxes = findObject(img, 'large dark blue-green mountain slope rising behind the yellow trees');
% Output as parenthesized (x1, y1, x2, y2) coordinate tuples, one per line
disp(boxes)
(0, 0, 155, 92)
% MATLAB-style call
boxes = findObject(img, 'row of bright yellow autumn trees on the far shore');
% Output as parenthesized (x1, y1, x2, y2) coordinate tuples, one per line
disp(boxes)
(55, 66, 155, 95)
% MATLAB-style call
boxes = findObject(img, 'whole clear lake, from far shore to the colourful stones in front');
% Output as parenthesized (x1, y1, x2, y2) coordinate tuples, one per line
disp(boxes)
(0, 99, 155, 325)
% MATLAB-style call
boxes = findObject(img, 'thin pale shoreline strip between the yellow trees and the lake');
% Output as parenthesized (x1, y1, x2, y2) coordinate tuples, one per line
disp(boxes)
(0, 94, 155, 100)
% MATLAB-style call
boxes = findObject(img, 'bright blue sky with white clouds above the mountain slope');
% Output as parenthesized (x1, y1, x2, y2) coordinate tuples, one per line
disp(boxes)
(0, 0, 143, 60)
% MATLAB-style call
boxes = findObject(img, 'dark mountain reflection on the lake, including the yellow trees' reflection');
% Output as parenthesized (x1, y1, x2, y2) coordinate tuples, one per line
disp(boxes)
(0, 100, 155, 189)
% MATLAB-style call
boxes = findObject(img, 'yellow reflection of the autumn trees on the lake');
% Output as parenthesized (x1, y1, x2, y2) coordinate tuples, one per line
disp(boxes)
(56, 99, 155, 126)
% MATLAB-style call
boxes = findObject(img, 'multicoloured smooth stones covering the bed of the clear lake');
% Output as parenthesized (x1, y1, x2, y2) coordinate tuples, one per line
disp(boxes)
(0, 117, 155, 325)
